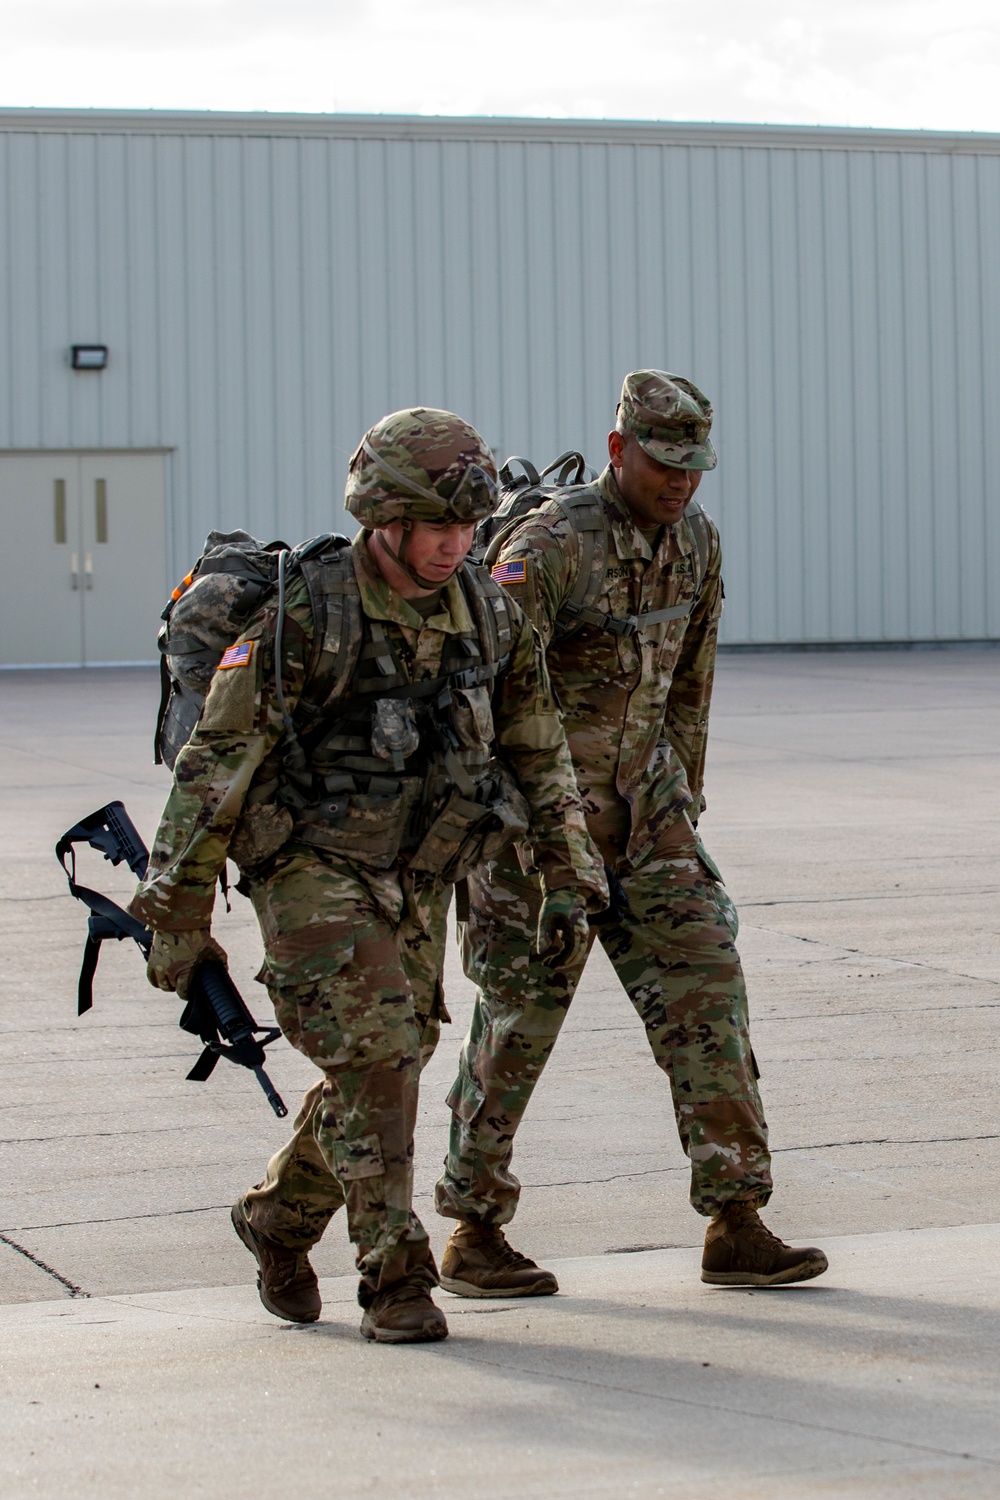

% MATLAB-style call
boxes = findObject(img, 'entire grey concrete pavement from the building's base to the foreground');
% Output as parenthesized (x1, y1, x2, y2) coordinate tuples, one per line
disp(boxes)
(0, 651, 1000, 1497)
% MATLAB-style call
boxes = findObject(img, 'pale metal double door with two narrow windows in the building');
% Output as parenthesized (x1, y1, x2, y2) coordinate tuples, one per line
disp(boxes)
(0, 452, 166, 666)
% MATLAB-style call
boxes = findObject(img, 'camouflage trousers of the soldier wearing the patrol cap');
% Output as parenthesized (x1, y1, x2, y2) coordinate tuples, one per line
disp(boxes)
(436, 819, 771, 1224)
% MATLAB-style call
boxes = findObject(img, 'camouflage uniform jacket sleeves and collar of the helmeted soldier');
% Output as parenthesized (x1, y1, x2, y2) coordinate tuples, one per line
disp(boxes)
(129, 533, 607, 932)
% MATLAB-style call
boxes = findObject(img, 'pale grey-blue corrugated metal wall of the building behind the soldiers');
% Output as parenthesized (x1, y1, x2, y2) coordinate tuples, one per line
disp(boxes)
(0, 111, 1000, 642)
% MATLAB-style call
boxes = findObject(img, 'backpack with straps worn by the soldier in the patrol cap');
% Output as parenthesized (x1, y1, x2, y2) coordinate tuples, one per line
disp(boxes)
(474, 449, 711, 639)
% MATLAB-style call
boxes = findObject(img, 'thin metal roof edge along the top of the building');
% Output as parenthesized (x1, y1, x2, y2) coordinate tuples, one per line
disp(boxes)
(0, 108, 1000, 155)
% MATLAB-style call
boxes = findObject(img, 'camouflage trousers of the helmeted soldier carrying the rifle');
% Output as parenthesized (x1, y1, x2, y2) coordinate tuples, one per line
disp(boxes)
(239, 854, 451, 1304)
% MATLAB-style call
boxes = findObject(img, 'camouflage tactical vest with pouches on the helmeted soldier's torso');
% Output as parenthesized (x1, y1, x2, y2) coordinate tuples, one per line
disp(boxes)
(231, 537, 529, 882)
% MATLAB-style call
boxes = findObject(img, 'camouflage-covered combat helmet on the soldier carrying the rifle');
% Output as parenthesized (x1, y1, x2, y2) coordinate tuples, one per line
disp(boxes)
(345, 407, 499, 528)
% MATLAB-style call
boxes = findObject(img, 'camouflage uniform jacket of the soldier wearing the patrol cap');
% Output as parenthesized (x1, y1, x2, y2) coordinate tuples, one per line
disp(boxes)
(498, 467, 723, 864)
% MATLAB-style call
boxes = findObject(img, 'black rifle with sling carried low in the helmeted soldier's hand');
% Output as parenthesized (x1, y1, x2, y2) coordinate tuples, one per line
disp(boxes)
(55, 803, 288, 1119)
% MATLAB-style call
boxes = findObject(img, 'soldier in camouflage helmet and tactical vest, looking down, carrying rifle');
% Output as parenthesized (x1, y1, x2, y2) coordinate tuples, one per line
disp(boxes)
(132, 408, 607, 1343)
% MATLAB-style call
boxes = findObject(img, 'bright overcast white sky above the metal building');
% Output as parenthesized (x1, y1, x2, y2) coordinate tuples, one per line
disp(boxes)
(0, 0, 1000, 131)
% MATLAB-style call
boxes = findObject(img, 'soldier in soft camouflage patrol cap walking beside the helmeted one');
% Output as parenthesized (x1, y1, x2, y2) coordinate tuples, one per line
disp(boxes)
(436, 369, 826, 1296)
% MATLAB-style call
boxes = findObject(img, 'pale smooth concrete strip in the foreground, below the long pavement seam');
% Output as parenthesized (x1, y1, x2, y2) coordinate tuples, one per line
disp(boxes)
(0, 1226, 1000, 1500)
